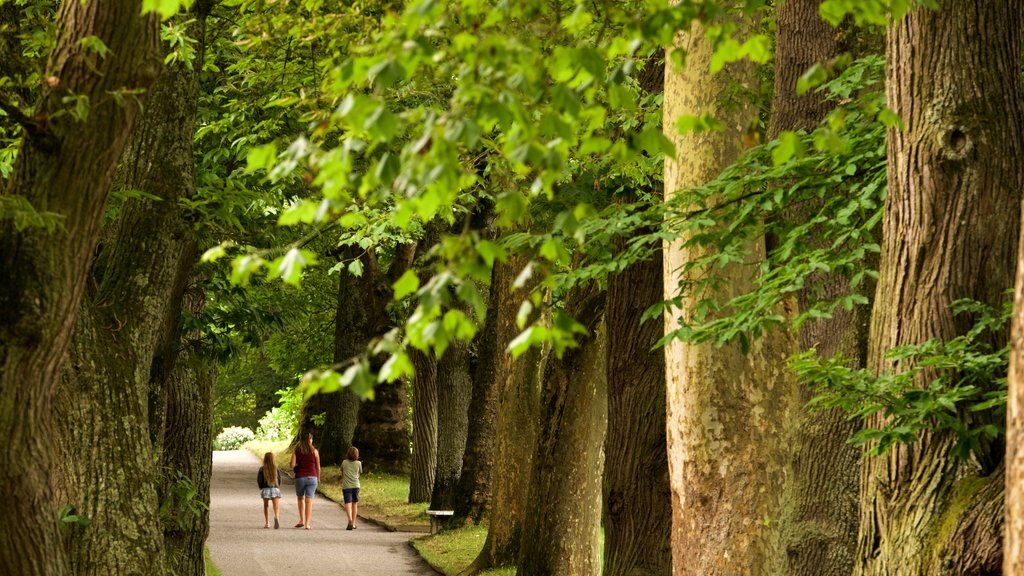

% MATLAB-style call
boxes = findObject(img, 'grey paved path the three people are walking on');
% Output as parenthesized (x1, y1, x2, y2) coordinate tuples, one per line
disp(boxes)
(207, 450, 435, 576)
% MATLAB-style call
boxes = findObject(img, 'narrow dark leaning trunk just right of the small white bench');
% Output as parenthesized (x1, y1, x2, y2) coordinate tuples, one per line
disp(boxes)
(452, 269, 499, 526)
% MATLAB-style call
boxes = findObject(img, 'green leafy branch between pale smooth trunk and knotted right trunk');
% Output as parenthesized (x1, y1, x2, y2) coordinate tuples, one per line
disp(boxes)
(645, 56, 887, 347)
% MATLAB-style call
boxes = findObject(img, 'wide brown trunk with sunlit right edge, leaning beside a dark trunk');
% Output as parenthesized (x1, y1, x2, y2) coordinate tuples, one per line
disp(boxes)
(516, 286, 608, 576)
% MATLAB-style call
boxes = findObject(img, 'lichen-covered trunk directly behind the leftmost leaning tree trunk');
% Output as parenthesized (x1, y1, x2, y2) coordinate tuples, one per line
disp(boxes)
(59, 11, 208, 574)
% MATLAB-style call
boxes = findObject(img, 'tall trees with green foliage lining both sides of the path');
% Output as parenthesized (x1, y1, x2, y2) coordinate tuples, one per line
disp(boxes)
(0, 0, 1024, 575)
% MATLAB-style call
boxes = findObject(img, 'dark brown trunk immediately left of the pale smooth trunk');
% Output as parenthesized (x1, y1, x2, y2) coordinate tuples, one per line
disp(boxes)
(602, 235, 672, 576)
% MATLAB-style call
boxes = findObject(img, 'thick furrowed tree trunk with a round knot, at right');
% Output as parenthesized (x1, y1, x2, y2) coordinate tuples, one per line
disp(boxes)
(855, 0, 1024, 576)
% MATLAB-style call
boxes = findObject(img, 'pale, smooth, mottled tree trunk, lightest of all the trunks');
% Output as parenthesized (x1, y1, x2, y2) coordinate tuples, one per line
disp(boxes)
(665, 12, 800, 576)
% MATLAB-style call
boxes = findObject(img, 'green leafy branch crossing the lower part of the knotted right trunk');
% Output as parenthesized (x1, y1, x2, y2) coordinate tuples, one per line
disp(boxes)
(790, 300, 1013, 458)
